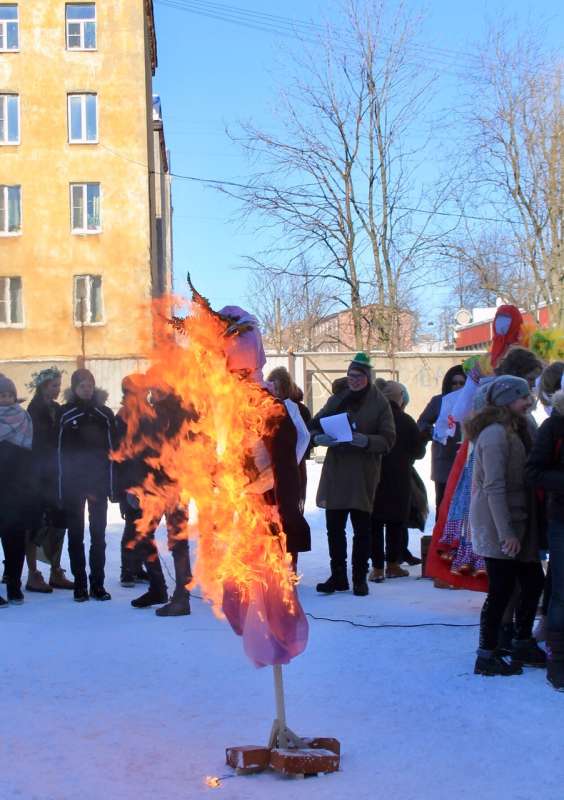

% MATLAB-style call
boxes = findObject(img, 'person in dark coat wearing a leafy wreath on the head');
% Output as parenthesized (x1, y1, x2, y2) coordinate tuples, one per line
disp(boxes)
(26, 367, 74, 593)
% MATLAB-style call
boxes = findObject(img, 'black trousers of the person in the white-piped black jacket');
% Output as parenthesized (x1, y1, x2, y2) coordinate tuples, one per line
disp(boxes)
(65, 494, 108, 590)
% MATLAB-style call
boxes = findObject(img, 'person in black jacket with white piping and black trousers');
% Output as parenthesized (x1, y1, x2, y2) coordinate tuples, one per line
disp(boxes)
(58, 369, 116, 602)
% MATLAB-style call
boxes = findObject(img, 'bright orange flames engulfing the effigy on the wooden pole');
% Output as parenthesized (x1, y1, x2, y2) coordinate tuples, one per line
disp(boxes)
(115, 298, 296, 617)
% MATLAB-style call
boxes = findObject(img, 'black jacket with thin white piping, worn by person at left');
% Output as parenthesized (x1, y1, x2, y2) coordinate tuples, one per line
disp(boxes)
(57, 398, 116, 503)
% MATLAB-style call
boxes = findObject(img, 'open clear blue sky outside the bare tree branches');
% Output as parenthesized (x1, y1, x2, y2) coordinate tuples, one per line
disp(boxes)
(154, 0, 563, 318)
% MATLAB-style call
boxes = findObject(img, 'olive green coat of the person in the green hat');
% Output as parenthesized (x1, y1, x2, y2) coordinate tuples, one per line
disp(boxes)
(310, 386, 396, 513)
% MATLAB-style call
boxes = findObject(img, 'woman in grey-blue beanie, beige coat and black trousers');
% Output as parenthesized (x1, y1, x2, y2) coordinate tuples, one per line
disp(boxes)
(466, 375, 546, 675)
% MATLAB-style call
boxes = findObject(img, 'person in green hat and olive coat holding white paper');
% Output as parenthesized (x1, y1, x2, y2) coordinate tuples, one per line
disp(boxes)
(310, 353, 396, 596)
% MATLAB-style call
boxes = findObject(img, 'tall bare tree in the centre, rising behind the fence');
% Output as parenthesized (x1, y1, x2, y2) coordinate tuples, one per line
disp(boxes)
(224, 0, 452, 352)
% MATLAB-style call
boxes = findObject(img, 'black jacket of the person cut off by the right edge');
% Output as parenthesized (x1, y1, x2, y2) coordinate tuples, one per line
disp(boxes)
(525, 400, 564, 522)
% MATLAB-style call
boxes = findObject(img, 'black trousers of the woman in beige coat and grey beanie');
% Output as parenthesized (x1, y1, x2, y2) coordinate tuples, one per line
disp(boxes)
(480, 558, 544, 650)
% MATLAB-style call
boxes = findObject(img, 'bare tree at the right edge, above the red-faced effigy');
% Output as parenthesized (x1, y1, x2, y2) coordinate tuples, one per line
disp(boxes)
(454, 23, 564, 325)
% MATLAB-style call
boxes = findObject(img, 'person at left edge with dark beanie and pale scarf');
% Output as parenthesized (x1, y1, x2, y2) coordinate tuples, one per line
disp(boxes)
(0, 375, 33, 608)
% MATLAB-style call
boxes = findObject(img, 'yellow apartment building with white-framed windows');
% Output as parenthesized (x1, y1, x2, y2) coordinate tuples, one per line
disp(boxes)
(0, 0, 171, 400)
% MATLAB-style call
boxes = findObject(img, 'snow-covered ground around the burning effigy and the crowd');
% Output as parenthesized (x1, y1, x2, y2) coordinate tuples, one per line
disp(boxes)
(0, 454, 564, 800)
